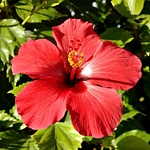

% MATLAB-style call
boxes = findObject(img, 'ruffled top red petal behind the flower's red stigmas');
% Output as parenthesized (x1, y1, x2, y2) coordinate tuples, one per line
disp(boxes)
(53, 19, 100, 69)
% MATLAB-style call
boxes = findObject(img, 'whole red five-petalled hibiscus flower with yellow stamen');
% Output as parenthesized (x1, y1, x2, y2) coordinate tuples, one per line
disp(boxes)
(11, 19, 141, 138)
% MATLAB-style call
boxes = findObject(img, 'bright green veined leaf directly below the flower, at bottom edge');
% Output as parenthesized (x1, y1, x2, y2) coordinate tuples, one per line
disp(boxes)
(33, 122, 82, 150)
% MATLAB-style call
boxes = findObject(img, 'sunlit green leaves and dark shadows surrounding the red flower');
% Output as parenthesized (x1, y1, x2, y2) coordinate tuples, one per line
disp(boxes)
(0, 0, 150, 150)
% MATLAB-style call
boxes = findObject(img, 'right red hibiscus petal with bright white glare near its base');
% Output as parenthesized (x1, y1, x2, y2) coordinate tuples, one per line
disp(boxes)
(79, 41, 141, 90)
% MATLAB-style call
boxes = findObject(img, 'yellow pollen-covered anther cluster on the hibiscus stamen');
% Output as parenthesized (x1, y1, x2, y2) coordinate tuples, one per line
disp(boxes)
(68, 50, 84, 68)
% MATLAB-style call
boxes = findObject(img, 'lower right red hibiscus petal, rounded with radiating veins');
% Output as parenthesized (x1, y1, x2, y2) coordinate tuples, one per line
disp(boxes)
(68, 82, 122, 138)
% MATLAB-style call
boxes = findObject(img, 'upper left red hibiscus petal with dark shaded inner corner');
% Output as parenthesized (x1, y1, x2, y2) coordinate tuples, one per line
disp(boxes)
(11, 39, 63, 78)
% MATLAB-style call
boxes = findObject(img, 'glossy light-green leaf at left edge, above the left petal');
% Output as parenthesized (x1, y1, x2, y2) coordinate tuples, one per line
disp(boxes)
(0, 19, 26, 64)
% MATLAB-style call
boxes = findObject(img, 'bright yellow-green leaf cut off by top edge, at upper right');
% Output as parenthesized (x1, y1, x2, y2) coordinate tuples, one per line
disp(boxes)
(111, 0, 144, 19)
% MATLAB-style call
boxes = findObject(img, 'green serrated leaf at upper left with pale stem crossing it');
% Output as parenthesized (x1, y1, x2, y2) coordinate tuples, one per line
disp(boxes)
(15, 1, 63, 23)
